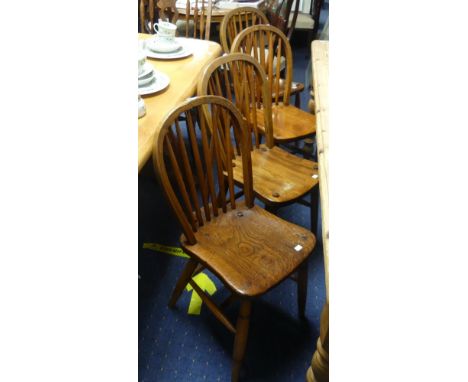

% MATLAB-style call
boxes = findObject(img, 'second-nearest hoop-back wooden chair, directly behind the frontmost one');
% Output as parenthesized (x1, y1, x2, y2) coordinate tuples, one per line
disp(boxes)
(197, 53, 319, 234)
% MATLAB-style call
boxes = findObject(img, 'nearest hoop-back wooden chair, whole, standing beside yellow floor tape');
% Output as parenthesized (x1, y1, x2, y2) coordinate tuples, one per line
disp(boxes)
(153, 96, 315, 381)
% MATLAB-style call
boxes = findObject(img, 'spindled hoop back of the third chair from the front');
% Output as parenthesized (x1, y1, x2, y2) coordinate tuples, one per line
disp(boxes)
(231, 25, 293, 105)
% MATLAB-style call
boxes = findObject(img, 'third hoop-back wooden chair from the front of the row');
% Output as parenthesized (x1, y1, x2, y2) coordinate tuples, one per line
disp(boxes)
(231, 25, 316, 148)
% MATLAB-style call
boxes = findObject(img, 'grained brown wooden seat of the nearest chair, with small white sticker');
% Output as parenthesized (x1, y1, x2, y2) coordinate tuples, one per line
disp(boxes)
(181, 201, 315, 297)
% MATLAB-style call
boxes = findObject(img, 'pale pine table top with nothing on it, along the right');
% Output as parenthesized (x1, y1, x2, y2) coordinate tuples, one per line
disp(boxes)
(312, 40, 329, 301)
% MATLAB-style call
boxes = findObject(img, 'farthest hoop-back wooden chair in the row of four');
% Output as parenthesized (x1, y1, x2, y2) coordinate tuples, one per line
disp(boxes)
(219, 7, 304, 107)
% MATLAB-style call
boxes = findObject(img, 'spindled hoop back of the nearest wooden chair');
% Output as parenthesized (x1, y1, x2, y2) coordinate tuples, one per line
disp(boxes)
(153, 96, 254, 245)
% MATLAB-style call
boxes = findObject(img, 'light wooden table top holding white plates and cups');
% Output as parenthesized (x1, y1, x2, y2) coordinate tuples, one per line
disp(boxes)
(138, 34, 222, 172)
